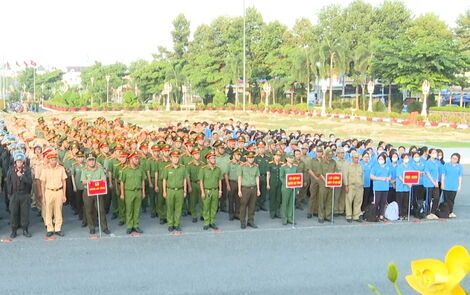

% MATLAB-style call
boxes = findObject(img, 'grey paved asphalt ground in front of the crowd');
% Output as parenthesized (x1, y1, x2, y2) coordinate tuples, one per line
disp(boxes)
(0, 166, 470, 295)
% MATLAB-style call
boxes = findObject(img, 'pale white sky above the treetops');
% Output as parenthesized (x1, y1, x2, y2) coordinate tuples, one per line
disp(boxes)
(0, 0, 470, 67)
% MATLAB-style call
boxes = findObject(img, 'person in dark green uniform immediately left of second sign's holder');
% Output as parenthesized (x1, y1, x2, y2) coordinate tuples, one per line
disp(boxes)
(267, 151, 284, 219)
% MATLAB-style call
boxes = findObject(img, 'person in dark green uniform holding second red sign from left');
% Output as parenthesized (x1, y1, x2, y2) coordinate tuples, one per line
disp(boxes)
(279, 152, 298, 225)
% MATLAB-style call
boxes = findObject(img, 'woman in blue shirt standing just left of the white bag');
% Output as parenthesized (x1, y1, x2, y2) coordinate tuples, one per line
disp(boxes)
(370, 153, 392, 221)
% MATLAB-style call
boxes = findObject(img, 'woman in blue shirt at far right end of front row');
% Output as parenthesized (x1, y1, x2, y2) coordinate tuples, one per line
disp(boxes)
(442, 153, 463, 218)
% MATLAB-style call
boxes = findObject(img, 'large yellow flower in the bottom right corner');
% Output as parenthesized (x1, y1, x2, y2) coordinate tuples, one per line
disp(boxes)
(406, 246, 470, 295)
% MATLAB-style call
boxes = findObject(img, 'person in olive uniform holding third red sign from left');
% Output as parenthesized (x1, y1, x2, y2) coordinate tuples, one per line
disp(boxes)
(318, 150, 338, 223)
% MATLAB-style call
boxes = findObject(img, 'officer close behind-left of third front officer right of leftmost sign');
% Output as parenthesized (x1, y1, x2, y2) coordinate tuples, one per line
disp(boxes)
(185, 148, 204, 223)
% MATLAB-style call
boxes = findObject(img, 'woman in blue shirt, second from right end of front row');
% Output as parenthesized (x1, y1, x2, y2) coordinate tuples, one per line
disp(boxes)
(423, 149, 441, 219)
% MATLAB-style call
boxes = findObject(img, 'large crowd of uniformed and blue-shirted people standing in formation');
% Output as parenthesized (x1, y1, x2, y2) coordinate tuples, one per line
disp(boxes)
(0, 118, 463, 236)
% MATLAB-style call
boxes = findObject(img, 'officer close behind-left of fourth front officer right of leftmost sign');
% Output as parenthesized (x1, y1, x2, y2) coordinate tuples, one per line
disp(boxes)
(225, 148, 242, 220)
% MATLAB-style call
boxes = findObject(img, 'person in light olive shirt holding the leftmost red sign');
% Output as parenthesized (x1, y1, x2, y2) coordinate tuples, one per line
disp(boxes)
(80, 153, 111, 235)
